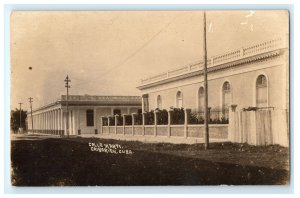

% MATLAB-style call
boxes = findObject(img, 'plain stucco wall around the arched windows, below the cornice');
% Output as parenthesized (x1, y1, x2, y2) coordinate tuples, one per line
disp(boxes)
(142, 58, 287, 111)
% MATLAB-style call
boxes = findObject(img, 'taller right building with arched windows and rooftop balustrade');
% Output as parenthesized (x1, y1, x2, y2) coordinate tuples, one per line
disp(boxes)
(138, 38, 289, 116)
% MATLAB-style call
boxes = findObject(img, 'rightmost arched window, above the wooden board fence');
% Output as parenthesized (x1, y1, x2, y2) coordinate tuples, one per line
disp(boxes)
(256, 75, 268, 107)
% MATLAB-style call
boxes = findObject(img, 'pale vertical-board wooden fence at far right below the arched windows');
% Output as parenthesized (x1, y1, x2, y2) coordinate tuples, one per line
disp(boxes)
(228, 106, 289, 147)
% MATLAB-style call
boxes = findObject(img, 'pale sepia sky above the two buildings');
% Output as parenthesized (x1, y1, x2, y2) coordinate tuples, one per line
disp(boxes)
(10, 10, 289, 110)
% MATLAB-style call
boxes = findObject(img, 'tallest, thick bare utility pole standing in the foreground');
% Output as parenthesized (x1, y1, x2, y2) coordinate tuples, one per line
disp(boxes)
(203, 11, 209, 150)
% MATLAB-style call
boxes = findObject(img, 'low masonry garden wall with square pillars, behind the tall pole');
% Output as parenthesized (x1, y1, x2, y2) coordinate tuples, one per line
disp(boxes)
(100, 109, 228, 139)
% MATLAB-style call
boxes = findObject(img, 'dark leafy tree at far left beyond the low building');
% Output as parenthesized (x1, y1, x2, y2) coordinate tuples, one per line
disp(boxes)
(10, 109, 27, 133)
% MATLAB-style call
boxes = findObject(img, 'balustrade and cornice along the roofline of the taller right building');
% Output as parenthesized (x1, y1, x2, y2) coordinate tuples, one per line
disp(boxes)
(137, 36, 288, 90)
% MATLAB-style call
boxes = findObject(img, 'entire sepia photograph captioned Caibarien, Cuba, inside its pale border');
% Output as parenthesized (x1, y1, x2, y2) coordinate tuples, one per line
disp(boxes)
(9, 10, 291, 187)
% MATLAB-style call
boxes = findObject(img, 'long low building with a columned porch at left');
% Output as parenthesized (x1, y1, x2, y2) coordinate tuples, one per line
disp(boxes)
(27, 95, 142, 135)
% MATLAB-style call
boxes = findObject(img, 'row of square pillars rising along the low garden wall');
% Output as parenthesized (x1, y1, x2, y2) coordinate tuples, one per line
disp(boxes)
(101, 109, 191, 137)
